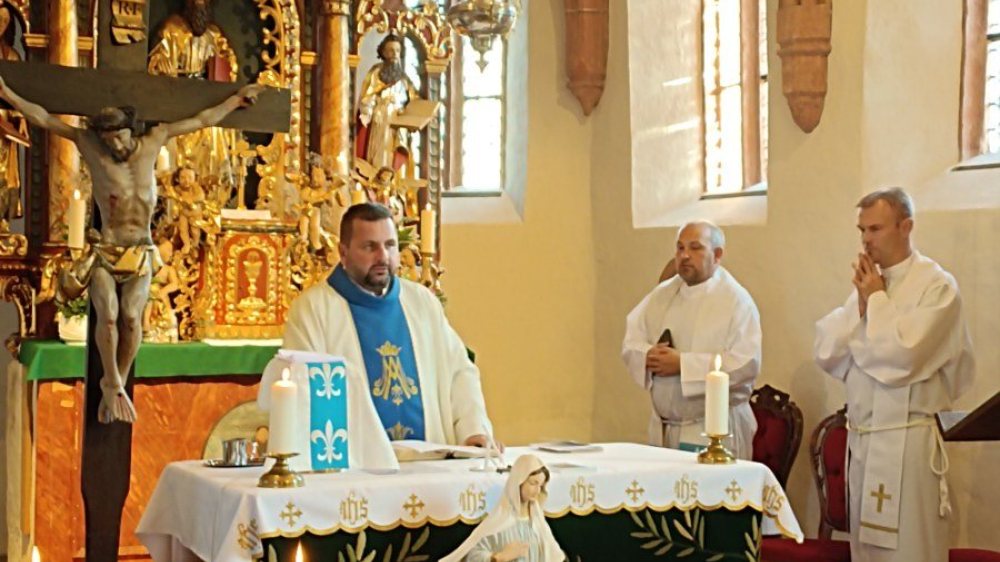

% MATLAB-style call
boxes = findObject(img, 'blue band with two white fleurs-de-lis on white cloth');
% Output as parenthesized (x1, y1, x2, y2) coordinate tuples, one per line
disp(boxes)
(306, 361, 348, 470)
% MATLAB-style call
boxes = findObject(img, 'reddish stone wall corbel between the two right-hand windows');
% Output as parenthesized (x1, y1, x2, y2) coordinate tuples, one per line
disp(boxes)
(777, 0, 833, 133)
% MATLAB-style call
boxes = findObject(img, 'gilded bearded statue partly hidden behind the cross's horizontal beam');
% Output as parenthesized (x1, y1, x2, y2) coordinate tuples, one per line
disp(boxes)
(148, 0, 238, 187)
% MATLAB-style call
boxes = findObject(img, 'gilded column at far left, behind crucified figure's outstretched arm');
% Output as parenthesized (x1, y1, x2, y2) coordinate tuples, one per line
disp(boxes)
(47, 0, 80, 244)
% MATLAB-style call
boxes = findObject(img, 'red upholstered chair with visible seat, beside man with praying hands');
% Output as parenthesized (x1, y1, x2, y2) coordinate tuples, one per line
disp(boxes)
(761, 407, 851, 562)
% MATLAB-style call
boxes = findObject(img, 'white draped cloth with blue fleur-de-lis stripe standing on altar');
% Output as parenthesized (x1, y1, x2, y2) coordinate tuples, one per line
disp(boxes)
(257, 349, 399, 471)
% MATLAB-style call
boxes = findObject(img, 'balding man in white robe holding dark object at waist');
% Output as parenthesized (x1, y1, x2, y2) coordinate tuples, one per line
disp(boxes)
(622, 221, 761, 459)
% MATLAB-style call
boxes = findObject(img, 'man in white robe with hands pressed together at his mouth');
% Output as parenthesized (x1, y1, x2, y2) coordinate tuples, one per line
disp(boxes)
(815, 188, 975, 562)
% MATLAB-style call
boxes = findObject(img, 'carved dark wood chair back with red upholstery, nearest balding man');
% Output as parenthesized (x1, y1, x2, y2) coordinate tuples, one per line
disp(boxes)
(750, 384, 802, 487)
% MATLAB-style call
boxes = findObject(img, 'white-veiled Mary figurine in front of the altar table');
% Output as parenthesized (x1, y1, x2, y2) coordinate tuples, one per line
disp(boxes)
(441, 455, 566, 562)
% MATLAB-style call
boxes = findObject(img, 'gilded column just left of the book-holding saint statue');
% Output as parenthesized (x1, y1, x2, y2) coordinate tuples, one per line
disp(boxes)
(318, 0, 352, 174)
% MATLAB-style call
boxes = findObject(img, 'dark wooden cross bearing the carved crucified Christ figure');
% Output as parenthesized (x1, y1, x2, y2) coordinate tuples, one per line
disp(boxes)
(0, 0, 291, 562)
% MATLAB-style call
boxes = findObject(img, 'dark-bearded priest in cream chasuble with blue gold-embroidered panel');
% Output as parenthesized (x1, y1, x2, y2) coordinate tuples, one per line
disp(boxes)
(284, 203, 492, 446)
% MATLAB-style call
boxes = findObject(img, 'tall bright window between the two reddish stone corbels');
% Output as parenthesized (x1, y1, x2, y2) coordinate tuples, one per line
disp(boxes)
(702, 0, 768, 196)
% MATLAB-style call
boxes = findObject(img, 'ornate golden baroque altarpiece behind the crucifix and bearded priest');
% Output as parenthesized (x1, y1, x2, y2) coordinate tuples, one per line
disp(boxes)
(0, 0, 453, 350)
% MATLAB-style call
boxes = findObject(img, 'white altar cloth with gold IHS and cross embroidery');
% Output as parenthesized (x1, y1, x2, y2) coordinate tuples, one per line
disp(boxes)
(136, 443, 802, 562)
